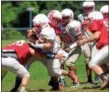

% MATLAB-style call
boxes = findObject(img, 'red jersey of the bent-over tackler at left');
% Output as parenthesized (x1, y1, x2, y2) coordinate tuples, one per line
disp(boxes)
(3, 40, 31, 65)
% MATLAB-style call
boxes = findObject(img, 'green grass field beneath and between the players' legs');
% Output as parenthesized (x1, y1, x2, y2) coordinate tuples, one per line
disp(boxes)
(2, 40, 109, 92)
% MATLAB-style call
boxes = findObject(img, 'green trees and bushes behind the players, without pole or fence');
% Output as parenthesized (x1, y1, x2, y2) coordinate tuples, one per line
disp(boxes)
(1, 1, 109, 38)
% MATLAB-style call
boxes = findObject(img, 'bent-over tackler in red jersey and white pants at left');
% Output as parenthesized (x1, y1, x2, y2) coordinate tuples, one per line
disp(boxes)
(2, 40, 43, 92)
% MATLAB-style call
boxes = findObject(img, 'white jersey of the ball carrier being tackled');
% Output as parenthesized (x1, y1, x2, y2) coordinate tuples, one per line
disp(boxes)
(40, 27, 60, 53)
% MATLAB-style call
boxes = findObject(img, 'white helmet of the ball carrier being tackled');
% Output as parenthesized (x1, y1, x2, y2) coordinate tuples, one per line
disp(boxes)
(32, 14, 49, 29)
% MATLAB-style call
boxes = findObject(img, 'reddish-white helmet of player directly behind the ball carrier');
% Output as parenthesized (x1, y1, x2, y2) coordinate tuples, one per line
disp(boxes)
(48, 10, 62, 28)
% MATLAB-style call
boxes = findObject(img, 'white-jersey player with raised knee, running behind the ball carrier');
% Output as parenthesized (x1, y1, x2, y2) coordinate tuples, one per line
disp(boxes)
(62, 8, 90, 86)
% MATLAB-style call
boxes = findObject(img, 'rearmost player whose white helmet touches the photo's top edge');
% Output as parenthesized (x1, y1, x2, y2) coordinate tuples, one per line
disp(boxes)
(78, 1, 100, 83)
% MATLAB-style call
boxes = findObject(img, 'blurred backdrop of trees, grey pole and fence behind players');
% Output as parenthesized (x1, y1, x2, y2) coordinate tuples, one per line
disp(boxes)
(1, 1, 108, 40)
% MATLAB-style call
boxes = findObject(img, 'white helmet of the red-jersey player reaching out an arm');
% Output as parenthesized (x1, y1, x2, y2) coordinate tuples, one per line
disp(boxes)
(88, 11, 103, 20)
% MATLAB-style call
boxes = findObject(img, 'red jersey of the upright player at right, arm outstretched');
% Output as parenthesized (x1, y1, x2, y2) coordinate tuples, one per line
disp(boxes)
(89, 20, 109, 49)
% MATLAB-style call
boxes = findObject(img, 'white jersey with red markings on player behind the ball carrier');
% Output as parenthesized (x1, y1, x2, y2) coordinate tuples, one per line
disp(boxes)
(63, 20, 82, 47)
